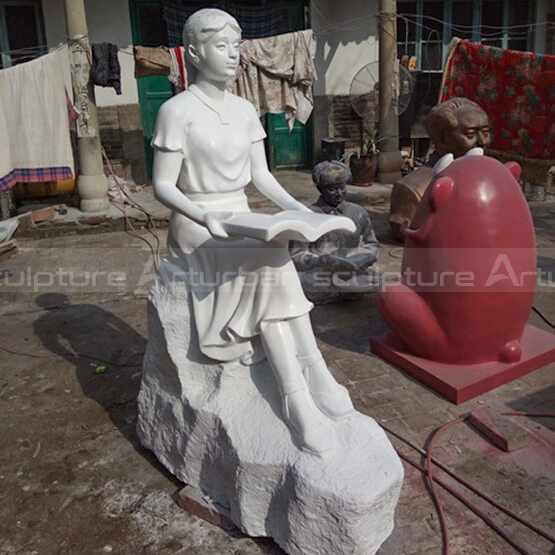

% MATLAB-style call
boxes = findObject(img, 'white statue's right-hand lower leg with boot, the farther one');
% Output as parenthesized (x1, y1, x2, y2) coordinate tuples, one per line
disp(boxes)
(285, 314, 354, 419)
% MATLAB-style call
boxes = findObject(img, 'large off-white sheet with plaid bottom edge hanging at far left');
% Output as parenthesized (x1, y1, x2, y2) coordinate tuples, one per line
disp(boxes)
(0, 50, 73, 191)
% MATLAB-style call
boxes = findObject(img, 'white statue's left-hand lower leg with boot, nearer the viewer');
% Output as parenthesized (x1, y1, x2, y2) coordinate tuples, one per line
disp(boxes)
(261, 321, 335, 454)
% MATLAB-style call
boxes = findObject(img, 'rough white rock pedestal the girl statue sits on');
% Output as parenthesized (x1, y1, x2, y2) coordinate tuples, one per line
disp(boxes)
(137, 261, 403, 555)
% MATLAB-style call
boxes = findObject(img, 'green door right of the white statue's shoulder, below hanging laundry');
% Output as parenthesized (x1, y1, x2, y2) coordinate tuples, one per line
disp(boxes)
(267, 114, 308, 171)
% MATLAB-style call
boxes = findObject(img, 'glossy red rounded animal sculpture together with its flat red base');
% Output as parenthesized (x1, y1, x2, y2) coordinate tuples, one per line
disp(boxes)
(371, 148, 555, 402)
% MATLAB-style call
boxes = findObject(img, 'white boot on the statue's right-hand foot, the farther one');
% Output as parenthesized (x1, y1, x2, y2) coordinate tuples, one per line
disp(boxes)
(297, 351, 355, 420)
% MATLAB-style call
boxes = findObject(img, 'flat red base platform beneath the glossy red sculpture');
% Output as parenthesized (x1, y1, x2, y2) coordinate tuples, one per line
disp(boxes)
(370, 324, 555, 405)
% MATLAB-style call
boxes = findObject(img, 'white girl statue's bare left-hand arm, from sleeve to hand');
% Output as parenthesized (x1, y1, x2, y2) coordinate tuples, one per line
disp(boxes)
(152, 149, 231, 238)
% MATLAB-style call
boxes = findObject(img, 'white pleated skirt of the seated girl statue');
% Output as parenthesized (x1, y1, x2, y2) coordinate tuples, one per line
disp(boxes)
(164, 191, 313, 361)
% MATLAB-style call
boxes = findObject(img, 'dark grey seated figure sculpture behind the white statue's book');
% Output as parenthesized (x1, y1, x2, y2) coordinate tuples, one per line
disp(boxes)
(290, 161, 379, 304)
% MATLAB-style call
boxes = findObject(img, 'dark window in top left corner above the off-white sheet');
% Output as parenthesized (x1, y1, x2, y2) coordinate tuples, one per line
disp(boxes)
(0, 0, 47, 69)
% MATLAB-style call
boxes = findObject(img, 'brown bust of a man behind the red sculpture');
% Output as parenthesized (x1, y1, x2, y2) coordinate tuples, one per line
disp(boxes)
(389, 97, 491, 241)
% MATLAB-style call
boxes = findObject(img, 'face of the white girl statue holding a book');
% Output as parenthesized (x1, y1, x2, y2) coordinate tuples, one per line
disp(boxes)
(195, 25, 241, 81)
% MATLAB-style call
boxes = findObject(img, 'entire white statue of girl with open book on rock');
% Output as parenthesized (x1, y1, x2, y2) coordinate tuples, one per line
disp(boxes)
(137, 9, 403, 555)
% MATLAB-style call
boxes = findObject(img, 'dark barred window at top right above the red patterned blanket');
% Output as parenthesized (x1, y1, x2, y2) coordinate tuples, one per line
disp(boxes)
(397, 0, 534, 71)
